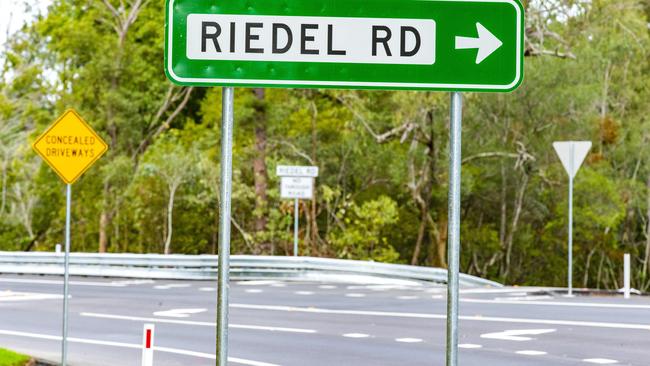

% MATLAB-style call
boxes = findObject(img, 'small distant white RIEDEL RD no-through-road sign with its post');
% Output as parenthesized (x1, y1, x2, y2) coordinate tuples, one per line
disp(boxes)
(275, 165, 318, 257)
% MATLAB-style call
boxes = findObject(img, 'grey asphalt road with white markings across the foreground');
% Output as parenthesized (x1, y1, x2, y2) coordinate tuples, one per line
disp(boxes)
(0, 275, 650, 366)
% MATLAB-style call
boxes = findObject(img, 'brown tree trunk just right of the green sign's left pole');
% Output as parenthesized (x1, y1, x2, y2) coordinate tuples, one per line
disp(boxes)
(253, 88, 269, 240)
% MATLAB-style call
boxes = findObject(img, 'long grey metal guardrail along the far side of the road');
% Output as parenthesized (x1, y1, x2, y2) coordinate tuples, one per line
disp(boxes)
(0, 252, 502, 287)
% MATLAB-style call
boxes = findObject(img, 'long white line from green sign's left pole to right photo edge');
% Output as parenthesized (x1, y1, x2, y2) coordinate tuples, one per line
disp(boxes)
(230, 303, 650, 330)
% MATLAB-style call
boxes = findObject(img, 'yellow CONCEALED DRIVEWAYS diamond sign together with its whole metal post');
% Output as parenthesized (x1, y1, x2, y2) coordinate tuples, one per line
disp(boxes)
(32, 109, 108, 366)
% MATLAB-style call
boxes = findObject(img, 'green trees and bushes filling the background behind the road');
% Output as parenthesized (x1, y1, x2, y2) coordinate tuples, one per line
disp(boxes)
(0, 0, 650, 290)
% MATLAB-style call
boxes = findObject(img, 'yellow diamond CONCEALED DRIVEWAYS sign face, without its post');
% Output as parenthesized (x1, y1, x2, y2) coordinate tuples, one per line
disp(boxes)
(32, 109, 108, 184)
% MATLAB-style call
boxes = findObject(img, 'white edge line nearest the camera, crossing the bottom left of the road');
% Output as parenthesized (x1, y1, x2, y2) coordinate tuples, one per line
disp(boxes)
(0, 329, 279, 366)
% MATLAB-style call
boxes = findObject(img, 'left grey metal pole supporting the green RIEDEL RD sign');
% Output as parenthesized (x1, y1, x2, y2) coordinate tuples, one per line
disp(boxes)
(217, 87, 235, 366)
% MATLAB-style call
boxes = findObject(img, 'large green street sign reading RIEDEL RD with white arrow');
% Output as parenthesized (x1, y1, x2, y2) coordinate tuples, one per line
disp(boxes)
(165, 0, 524, 92)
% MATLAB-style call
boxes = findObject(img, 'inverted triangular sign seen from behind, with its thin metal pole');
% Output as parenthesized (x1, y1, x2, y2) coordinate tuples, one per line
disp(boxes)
(553, 141, 591, 296)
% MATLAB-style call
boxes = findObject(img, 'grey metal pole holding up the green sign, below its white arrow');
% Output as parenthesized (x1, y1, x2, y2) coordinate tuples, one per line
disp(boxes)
(447, 92, 463, 366)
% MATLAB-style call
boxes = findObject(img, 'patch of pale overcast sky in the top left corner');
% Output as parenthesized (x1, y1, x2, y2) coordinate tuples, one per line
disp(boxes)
(0, 0, 52, 48)
